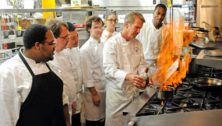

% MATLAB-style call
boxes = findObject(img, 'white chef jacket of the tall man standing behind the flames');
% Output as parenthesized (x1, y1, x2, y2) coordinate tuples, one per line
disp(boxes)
(137, 20, 163, 65)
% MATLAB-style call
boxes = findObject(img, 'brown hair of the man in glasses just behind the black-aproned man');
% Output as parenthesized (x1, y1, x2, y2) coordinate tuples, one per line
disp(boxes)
(45, 19, 68, 38)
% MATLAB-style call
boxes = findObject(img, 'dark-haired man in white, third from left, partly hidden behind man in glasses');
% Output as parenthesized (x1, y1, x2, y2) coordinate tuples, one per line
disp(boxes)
(63, 22, 83, 126)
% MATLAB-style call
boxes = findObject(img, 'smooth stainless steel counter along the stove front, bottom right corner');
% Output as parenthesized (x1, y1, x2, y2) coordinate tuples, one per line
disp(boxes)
(134, 110, 222, 126)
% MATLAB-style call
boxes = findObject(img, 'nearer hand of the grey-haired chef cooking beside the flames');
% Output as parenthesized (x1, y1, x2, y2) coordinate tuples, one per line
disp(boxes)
(126, 73, 146, 89)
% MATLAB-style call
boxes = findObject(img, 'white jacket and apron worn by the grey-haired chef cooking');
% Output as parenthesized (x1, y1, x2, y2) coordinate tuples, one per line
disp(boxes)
(103, 33, 147, 126)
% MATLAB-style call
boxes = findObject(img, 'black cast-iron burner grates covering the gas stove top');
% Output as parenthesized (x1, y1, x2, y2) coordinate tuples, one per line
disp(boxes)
(136, 80, 222, 116)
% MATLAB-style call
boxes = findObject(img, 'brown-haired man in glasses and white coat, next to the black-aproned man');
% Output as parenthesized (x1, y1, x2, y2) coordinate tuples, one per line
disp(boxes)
(46, 19, 76, 126)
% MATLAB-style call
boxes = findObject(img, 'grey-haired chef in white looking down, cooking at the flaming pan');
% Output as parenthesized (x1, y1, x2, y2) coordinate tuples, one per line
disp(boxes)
(103, 12, 147, 126)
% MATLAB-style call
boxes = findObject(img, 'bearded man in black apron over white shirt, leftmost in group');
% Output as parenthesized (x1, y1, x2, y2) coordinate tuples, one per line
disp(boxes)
(0, 24, 65, 126)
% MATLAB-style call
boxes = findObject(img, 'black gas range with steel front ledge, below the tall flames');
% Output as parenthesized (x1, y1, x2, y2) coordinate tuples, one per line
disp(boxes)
(123, 66, 222, 126)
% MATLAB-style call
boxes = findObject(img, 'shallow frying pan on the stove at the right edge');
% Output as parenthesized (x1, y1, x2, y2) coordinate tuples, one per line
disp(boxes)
(191, 77, 222, 91)
